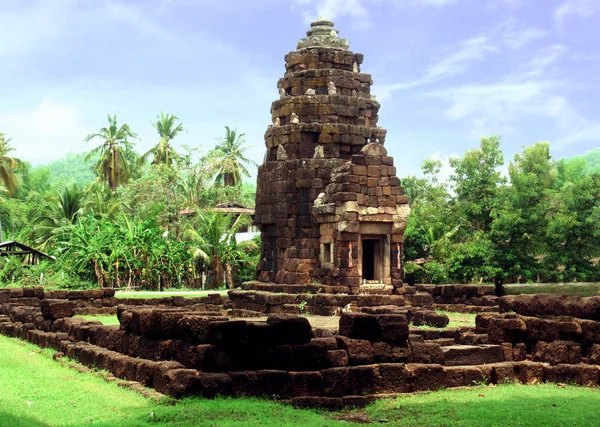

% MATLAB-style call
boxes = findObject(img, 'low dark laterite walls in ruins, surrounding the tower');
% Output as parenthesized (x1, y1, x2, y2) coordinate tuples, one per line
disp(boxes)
(0, 287, 600, 409)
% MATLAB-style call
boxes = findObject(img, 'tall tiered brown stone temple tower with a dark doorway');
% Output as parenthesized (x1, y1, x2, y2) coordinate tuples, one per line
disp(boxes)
(255, 19, 410, 294)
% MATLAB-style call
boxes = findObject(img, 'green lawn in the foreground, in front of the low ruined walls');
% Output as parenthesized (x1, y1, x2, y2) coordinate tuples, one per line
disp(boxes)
(0, 336, 600, 427)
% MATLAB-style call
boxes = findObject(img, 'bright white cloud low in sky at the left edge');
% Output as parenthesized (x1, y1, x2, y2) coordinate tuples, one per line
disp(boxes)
(0, 98, 89, 165)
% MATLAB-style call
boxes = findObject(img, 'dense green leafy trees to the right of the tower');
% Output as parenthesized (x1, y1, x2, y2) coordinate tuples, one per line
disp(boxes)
(404, 137, 600, 292)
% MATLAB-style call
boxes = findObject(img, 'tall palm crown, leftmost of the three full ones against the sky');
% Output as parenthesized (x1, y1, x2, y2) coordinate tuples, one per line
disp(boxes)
(84, 114, 138, 191)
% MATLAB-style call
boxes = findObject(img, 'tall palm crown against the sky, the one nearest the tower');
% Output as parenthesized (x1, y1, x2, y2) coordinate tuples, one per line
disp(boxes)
(206, 126, 258, 186)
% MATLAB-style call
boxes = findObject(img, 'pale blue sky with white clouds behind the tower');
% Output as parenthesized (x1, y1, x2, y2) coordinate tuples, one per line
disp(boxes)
(0, 0, 600, 181)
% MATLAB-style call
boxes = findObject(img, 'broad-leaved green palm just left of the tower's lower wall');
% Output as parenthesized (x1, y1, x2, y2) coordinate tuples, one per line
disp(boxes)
(183, 211, 250, 288)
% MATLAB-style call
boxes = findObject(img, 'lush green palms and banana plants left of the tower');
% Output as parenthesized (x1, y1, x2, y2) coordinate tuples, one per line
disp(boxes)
(0, 122, 260, 290)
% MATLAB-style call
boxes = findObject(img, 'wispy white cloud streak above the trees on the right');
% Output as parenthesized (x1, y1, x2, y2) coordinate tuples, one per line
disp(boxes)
(423, 45, 600, 149)
